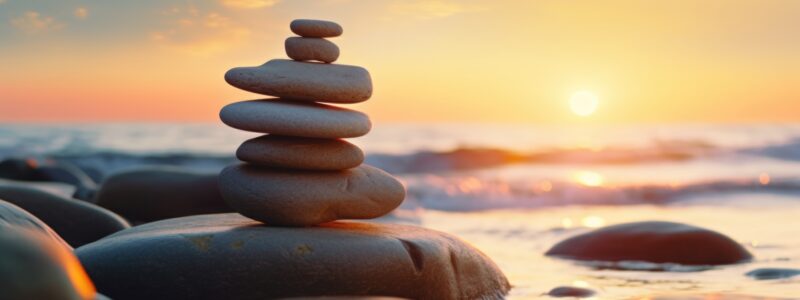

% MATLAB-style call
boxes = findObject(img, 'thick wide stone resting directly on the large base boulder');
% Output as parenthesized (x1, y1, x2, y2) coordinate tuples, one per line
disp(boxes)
(219, 164, 406, 226)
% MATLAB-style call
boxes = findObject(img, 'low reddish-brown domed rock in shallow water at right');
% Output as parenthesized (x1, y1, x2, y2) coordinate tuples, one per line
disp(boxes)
(546, 221, 752, 265)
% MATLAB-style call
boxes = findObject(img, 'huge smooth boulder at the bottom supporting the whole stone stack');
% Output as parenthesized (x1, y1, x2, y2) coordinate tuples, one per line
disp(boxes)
(76, 214, 509, 299)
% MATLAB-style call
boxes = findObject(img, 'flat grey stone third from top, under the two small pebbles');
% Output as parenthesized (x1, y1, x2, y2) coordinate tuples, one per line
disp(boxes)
(225, 59, 372, 103)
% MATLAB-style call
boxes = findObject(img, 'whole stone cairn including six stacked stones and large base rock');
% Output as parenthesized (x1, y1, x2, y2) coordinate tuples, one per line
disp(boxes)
(76, 20, 510, 300)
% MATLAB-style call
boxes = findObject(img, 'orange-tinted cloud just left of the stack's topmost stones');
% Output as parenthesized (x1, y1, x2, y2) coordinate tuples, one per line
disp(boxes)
(150, 6, 250, 57)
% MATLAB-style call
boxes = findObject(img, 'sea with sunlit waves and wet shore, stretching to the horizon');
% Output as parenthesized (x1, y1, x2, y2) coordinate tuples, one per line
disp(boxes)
(0, 124, 800, 299)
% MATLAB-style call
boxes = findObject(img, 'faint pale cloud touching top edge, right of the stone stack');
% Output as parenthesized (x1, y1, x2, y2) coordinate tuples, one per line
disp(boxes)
(390, 0, 484, 19)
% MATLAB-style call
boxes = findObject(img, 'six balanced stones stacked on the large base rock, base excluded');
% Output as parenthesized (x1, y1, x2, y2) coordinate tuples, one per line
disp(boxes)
(219, 20, 405, 226)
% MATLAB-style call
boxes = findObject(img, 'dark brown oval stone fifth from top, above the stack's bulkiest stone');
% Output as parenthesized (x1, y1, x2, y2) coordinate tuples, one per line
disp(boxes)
(236, 134, 364, 170)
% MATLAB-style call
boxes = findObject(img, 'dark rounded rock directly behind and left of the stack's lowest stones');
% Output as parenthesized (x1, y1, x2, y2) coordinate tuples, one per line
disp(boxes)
(95, 168, 233, 224)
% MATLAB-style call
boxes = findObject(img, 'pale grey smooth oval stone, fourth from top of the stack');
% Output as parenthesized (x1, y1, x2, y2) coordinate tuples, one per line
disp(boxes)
(219, 99, 372, 139)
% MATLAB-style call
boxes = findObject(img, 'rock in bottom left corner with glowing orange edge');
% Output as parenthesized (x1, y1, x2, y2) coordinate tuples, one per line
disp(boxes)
(0, 224, 102, 300)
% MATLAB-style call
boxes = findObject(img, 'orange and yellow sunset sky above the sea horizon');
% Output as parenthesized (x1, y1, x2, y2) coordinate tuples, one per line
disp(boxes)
(0, 0, 800, 124)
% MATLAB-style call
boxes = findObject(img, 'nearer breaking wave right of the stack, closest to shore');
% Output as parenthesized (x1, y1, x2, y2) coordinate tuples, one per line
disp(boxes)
(403, 175, 800, 211)
